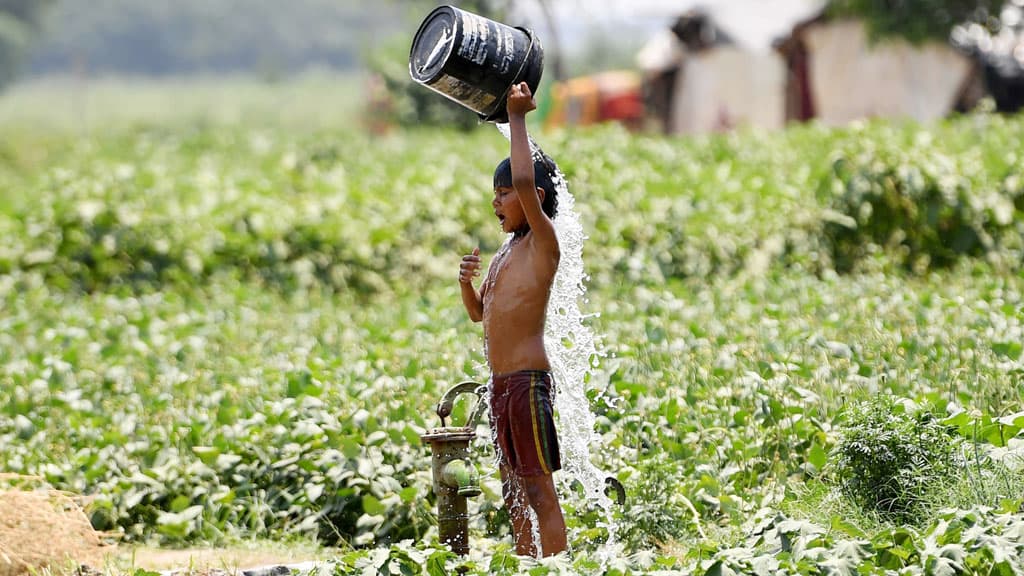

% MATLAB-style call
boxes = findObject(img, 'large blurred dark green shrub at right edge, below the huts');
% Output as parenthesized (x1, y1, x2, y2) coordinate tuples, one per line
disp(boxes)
(824, 132, 1020, 272)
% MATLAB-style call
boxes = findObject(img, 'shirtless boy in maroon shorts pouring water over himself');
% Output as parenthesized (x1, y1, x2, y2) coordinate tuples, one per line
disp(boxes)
(459, 82, 566, 557)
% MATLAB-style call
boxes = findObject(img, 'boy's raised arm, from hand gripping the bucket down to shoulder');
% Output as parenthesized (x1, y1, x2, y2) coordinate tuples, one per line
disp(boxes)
(508, 82, 558, 254)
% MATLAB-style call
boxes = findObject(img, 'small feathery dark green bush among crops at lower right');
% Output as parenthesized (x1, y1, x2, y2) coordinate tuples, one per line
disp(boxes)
(829, 396, 964, 522)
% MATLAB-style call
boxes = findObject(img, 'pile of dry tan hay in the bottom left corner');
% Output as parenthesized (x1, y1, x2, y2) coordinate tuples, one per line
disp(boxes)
(0, 488, 110, 576)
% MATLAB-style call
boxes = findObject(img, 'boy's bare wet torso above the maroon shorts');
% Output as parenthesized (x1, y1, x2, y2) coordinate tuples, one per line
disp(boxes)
(482, 233, 554, 374)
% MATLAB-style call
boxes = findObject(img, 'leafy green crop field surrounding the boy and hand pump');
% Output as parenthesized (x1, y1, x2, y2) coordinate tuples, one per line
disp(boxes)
(0, 77, 1024, 576)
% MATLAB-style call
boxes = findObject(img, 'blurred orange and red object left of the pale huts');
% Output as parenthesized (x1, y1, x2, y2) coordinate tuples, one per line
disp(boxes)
(546, 70, 644, 129)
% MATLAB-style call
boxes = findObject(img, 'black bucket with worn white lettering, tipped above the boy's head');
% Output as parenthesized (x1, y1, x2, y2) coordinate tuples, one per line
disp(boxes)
(409, 6, 544, 123)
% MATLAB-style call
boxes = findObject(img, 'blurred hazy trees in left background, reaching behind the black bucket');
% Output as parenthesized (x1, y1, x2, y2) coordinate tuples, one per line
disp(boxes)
(0, 0, 511, 128)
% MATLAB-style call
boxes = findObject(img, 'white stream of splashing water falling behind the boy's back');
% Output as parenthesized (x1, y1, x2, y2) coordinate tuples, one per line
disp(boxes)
(497, 124, 617, 561)
